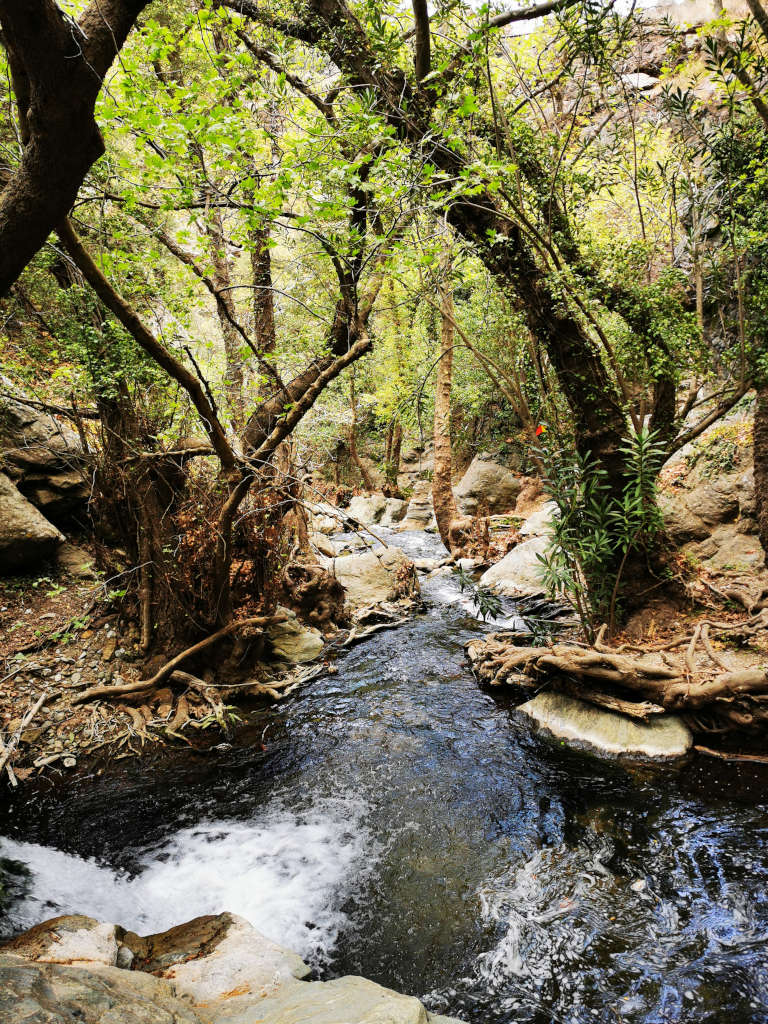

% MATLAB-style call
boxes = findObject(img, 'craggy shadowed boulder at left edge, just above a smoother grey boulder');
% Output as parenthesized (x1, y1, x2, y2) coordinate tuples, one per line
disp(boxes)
(0, 388, 90, 524)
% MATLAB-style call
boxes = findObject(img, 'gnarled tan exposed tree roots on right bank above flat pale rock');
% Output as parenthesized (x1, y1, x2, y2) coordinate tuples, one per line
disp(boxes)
(467, 609, 768, 733)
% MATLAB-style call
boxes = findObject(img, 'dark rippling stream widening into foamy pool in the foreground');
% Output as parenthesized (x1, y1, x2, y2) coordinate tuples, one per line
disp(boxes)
(0, 531, 768, 1024)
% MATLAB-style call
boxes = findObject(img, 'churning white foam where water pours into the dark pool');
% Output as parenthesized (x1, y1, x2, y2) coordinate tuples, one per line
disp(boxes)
(0, 799, 375, 964)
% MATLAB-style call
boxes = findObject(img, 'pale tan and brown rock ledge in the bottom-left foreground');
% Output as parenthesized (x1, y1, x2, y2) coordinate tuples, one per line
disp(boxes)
(0, 913, 460, 1024)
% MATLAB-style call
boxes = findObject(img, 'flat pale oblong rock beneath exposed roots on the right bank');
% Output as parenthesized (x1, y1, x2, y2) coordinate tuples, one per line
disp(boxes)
(517, 692, 693, 761)
